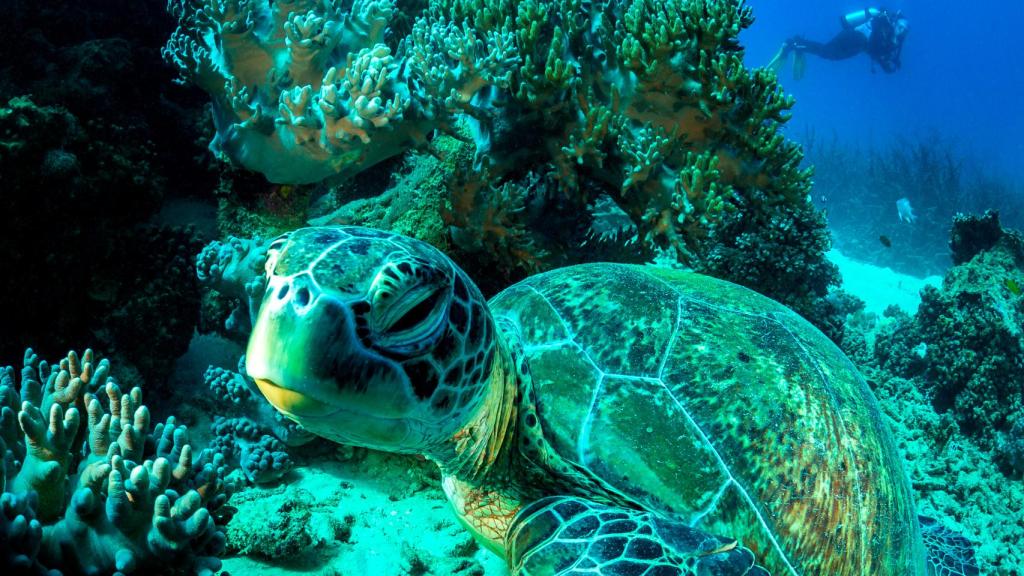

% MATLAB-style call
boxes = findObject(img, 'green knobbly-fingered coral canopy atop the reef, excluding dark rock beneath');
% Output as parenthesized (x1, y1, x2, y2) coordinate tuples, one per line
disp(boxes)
(172, 0, 809, 251)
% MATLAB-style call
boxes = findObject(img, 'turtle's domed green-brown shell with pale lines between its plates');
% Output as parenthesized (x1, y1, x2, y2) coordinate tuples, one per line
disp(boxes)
(492, 263, 926, 576)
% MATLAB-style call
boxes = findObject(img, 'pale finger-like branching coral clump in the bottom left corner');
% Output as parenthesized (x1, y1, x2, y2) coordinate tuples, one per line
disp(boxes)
(0, 348, 227, 575)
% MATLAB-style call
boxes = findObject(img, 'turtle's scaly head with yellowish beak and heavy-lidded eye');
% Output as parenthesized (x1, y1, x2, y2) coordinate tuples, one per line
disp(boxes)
(246, 227, 497, 453)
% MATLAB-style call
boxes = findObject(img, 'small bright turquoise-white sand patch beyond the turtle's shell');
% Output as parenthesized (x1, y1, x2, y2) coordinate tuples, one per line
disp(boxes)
(825, 250, 942, 315)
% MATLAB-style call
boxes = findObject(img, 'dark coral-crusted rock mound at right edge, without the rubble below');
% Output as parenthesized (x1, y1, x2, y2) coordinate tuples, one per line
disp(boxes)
(881, 212, 1024, 449)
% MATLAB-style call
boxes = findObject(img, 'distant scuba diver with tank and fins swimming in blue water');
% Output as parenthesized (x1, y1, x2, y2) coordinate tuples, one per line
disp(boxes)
(768, 8, 909, 80)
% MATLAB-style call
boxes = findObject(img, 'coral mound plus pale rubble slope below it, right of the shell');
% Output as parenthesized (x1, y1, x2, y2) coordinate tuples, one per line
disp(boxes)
(842, 213, 1024, 576)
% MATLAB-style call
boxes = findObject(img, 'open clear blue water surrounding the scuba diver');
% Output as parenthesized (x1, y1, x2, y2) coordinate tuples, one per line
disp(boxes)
(741, 0, 1024, 181)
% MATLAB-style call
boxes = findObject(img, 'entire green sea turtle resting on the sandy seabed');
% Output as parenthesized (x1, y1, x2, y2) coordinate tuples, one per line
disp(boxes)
(247, 227, 977, 576)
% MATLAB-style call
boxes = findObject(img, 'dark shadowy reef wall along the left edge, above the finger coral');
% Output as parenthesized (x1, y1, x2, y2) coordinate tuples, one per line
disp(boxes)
(0, 0, 228, 385)
